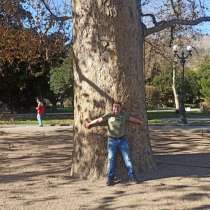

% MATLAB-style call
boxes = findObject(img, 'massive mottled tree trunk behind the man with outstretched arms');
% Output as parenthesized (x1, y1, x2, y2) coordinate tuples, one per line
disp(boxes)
(72, 0, 154, 177)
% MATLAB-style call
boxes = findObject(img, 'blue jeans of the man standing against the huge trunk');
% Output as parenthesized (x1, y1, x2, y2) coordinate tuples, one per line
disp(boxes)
(107, 136, 134, 179)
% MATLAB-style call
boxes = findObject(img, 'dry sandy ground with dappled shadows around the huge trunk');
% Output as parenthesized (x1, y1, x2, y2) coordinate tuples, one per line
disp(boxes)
(0, 126, 210, 210)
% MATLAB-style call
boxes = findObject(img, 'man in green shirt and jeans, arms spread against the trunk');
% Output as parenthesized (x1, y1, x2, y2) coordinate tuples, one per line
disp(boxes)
(85, 102, 143, 186)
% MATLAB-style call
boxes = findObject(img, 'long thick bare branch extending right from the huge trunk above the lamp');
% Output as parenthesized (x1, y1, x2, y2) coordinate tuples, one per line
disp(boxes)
(144, 16, 210, 37)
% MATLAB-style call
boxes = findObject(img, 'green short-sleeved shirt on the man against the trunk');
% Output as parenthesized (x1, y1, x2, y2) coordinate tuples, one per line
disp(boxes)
(102, 112, 129, 138)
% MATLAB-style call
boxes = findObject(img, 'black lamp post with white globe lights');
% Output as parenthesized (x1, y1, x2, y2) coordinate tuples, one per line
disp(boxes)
(173, 45, 192, 124)
